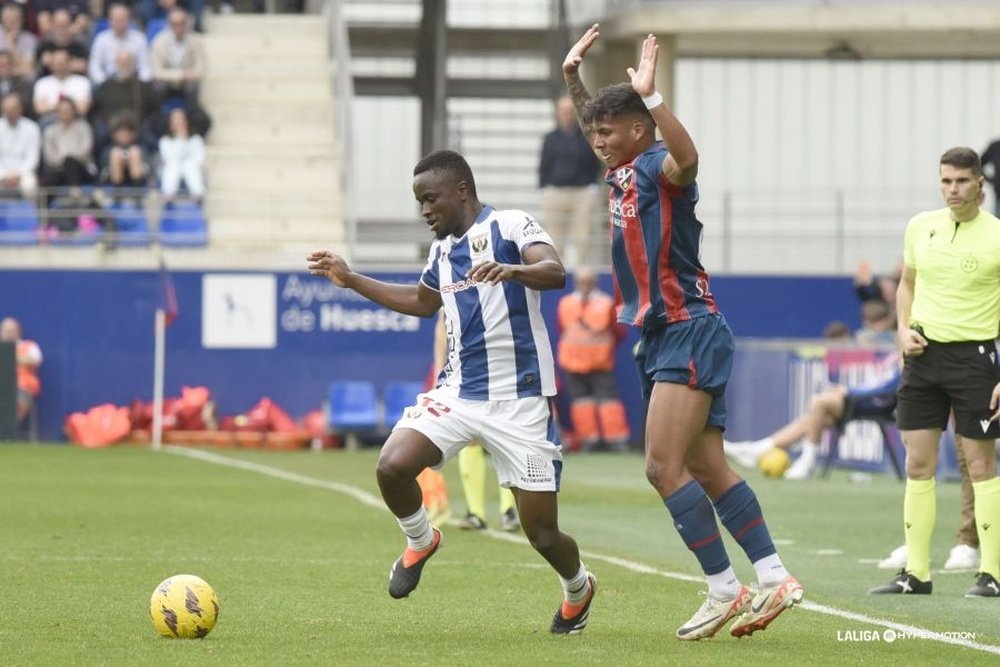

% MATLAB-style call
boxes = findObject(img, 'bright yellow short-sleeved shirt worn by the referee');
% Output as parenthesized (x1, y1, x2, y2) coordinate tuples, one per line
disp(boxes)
(903, 208, 1000, 343)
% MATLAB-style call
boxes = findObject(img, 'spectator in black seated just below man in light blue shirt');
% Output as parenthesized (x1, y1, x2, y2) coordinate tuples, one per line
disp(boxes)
(91, 49, 160, 155)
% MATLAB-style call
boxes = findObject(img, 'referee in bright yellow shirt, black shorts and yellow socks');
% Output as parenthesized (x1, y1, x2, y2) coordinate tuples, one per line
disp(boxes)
(870, 147, 1000, 598)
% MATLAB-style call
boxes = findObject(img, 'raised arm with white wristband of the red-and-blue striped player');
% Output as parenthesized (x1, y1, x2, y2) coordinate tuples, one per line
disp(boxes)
(625, 35, 698, 187)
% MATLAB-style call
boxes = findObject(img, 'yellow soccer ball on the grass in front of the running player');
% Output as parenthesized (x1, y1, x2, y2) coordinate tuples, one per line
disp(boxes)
(149, 574, 219, 639)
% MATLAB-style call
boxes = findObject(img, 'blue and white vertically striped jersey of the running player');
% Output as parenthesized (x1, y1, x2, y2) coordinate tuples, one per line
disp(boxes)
(420, 206, 556, 401)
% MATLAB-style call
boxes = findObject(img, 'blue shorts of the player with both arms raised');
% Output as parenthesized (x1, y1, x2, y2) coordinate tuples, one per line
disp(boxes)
(635, 313, 735, 429)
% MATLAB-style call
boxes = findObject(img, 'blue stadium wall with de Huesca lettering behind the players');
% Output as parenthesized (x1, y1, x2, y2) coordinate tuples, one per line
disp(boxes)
(0, 270, 858, 440)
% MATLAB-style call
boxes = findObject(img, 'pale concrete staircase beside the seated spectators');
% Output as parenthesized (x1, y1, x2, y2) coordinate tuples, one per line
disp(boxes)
(202, 14, 346, 265)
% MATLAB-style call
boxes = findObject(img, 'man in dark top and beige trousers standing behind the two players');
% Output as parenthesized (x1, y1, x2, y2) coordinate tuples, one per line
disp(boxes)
(538, 97, 600, 265)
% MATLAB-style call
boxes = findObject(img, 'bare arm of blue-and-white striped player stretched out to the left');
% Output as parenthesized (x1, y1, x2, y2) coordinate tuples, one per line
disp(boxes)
(307, 250, 441, 317)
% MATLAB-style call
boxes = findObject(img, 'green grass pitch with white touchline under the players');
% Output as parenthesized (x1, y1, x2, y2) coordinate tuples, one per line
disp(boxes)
(0, 445, 1000, 667)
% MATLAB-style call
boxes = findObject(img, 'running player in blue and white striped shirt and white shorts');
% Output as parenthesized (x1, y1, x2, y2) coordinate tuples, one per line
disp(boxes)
(309, 150, 596, 634)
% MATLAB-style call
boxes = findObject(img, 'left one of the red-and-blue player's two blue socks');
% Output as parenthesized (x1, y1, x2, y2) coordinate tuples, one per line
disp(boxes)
(663, 480, 729, 575)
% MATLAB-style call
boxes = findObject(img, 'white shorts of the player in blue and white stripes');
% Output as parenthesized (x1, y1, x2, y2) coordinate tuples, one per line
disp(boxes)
(393, 389, 562, 491)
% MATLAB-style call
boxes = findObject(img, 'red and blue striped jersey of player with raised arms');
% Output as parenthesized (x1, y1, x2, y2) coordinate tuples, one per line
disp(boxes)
(605, 142, 719, 326)
